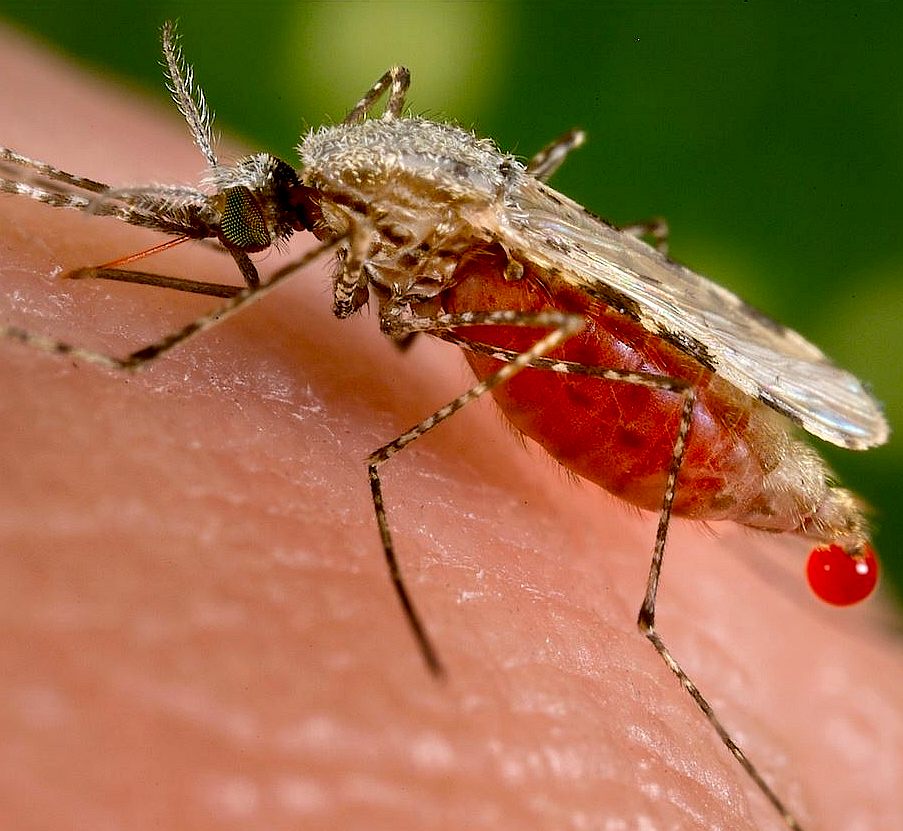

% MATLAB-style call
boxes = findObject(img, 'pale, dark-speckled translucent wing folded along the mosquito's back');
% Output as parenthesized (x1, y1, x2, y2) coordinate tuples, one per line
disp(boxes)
(497, 174, 889, 450)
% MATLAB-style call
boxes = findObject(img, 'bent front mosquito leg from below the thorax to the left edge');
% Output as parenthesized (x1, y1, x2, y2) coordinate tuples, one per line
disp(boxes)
(0, 237, 344, 370)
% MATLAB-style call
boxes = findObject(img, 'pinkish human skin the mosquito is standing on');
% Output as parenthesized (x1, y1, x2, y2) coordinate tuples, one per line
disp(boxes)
(0, 24, 903, 831)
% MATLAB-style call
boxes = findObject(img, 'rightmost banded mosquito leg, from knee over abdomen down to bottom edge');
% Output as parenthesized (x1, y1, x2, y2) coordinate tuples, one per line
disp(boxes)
(637, 388, 802, 831)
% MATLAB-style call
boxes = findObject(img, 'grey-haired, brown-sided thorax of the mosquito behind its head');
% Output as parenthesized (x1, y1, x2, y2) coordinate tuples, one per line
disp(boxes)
(298, 118, 523, 302)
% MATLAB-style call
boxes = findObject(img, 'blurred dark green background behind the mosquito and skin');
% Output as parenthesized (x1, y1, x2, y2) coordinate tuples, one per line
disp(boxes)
(0, 0, 903, 597)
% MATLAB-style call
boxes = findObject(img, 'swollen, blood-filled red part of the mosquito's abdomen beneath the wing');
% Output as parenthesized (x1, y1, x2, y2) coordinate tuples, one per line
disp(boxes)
(442, 249, 763, 522)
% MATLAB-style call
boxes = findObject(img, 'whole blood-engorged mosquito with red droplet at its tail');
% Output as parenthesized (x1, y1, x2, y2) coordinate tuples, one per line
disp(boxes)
(0, 23, 889, 829)
